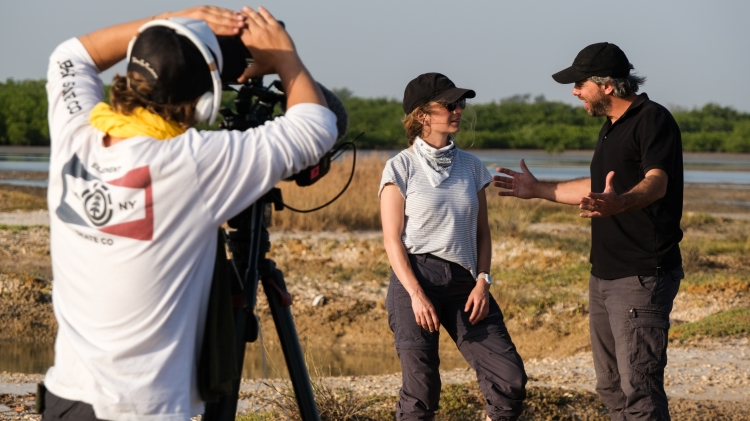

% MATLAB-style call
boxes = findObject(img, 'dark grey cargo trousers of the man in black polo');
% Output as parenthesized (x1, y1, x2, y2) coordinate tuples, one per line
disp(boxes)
(589, 267, 685, 421)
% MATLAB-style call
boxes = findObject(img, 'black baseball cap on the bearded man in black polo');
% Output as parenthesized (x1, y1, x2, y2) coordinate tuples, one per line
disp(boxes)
(552, 42, 633, 83)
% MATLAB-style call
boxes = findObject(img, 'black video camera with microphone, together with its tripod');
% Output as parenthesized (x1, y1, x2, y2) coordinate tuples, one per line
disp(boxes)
(204, 73, 356, 421)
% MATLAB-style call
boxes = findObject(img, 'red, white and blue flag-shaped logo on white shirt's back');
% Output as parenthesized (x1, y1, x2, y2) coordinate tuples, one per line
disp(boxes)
(55, 155, 154, 241)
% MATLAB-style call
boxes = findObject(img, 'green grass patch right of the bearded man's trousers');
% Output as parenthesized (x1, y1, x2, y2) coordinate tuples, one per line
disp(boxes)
(669, 308, 750, 340)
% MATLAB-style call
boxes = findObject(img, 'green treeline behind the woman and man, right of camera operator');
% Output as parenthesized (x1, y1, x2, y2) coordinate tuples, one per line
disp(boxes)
(342, 91, 750, 152)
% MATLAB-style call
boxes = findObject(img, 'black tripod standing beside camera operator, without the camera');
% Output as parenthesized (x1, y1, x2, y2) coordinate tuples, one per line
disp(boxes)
(203, 188, 320, 421)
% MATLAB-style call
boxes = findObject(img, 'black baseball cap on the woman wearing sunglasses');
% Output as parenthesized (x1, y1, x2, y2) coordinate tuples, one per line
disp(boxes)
(403, 73, 477, 114)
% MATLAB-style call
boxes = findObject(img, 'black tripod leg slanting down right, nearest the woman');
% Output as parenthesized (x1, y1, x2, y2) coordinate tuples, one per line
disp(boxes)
(263, 269, 320, 421)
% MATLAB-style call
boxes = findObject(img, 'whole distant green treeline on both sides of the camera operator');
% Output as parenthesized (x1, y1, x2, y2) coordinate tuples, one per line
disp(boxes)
(0, 79, 750, 152)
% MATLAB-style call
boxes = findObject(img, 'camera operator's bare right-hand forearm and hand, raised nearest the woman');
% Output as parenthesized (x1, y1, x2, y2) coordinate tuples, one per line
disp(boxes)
(239, 7, 327, 109)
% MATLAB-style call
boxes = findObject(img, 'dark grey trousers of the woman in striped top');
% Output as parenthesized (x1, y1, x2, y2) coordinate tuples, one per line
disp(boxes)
(386, 254, 527, 421)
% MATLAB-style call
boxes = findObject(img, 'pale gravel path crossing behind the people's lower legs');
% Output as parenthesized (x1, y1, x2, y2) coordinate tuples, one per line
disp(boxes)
(0, 338, 750, 420)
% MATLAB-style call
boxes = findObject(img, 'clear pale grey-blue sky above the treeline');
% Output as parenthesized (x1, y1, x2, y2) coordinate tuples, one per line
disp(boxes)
(0, 0, 750, 112)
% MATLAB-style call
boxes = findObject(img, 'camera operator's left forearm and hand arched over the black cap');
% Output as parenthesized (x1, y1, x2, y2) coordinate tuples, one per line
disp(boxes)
(79, 6, 245, 72)
